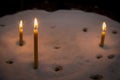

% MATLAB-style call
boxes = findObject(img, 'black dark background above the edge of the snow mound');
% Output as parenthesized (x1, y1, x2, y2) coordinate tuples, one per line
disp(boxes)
(0, 0, 120, 22)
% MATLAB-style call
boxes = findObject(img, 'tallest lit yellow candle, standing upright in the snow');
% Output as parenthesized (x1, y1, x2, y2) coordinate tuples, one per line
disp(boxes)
(34, 18, 38, 69)
